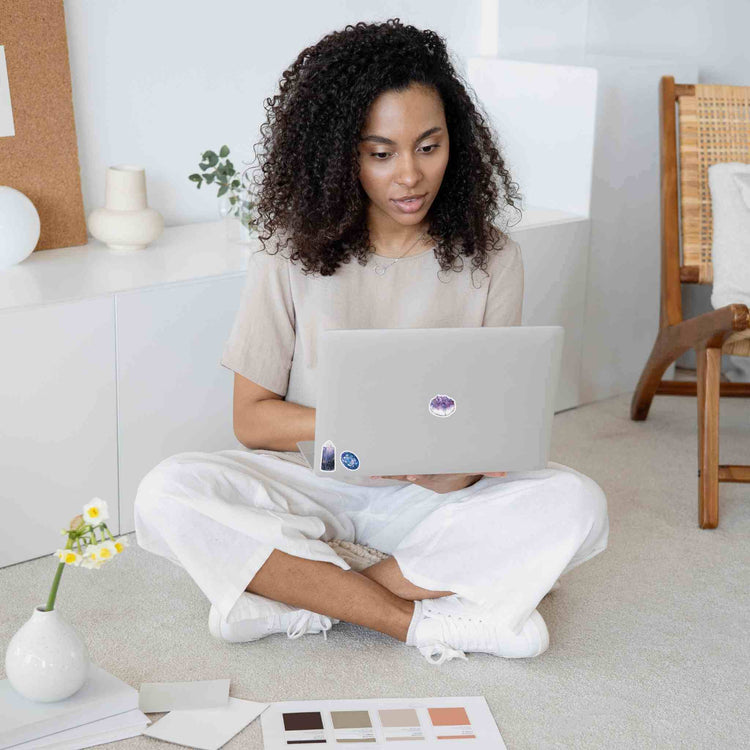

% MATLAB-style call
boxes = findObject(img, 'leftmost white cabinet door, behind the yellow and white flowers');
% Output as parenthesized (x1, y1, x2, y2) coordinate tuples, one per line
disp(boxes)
(0, 297, 119, 568)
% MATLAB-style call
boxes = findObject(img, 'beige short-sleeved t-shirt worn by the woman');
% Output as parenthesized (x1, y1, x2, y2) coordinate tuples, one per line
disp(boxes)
(220, 240, 523, 408)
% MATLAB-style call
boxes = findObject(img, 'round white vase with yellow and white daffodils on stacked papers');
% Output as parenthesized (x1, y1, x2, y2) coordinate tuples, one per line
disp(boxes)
(5, 497, 127, 703)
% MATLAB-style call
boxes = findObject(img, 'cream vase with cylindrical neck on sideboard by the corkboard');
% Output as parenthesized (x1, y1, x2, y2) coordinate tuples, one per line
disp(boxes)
(88, 164, 164, 252)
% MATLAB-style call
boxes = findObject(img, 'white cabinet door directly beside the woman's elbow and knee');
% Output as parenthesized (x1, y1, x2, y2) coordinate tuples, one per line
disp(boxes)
(115, 273, 245, 534)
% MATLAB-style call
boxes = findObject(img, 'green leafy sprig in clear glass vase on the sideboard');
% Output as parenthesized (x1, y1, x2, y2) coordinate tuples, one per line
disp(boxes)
(188, 146, 257, 242)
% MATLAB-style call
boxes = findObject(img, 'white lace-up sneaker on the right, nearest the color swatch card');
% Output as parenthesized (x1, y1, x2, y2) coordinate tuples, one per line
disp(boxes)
(406, 594, 549, 664)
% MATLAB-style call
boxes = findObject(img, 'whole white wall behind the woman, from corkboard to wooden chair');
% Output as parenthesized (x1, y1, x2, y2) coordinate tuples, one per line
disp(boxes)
(65, 0, 750, 401)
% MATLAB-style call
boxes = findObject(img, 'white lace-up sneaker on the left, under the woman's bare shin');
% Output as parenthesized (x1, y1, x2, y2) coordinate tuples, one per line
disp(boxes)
(208, 591, 339, 643)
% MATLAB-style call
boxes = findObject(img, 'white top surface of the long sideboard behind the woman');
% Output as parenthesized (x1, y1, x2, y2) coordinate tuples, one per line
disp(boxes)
(0, 207, 587, 311)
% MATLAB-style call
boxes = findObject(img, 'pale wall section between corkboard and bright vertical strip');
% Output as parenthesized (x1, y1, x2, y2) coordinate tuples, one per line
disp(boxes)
(65, 0, 480, 226)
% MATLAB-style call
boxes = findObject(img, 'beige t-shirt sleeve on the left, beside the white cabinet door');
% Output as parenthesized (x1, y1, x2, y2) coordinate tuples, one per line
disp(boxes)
(219, 251, 295, 396)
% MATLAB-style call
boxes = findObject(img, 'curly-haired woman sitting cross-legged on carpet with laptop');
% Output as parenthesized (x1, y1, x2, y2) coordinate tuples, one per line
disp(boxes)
(135, 19, 609, 664)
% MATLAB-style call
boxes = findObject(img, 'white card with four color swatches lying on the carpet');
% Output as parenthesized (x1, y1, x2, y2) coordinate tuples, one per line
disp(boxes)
(261, 696, 505, 750)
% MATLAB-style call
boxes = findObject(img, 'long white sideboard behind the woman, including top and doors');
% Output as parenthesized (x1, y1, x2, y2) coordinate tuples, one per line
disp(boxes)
(0, 214, 589, 567)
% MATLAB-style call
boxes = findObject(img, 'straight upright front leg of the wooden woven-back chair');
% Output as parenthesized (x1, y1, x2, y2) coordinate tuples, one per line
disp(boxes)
(695, 346, 721, 529)
